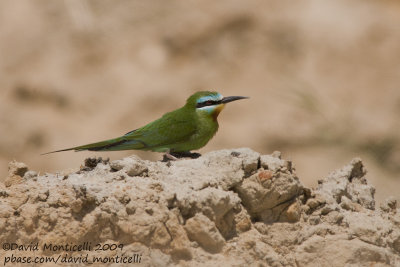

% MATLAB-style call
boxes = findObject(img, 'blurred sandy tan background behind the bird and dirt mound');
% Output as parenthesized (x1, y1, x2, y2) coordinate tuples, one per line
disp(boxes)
(0, 0, 400, 203)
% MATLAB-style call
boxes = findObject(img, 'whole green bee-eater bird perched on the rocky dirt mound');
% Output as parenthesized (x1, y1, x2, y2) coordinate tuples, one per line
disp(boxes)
(42, 91, 249, 160)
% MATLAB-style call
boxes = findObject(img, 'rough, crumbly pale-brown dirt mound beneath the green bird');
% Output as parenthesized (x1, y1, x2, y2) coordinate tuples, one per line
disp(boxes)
(0, 148, 400, 266)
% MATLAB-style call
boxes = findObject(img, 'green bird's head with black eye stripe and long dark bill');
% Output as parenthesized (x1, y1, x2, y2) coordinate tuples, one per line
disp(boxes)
(186, 91, 248, 119)
